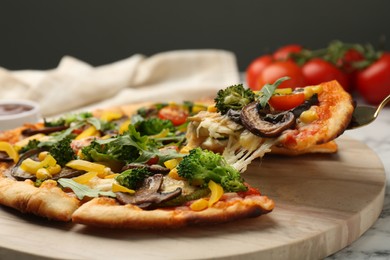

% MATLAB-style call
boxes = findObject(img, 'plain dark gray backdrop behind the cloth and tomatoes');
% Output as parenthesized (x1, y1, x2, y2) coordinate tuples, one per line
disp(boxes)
(0, 0, 390, 70)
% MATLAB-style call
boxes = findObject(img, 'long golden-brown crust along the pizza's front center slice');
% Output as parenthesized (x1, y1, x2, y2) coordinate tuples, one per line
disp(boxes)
(72, 195, 274, 229)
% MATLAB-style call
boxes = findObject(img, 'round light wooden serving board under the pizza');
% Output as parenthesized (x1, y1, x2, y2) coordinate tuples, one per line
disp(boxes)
(0, 137, 386, 259)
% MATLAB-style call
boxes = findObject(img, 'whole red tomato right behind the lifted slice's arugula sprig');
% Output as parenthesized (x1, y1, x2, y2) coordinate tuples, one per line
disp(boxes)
(254, 61, 305, 90)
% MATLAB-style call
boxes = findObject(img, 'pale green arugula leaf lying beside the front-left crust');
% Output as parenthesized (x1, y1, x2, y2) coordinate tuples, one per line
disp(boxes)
(58, 178, 116, 200)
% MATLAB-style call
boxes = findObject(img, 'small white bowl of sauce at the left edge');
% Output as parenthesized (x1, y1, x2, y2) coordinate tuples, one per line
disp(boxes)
(0, 100, 41, 130)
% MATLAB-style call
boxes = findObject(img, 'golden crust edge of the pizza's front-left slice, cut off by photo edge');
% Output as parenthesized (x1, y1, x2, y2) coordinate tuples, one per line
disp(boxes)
(0, 177, 80, 221)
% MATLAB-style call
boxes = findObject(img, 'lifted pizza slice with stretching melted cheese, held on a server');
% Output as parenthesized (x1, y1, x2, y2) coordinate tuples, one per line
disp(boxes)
(187, 79, 354, 172)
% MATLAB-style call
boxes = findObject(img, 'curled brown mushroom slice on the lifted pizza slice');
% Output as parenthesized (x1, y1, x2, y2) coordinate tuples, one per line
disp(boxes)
(240, 102, 295, 137)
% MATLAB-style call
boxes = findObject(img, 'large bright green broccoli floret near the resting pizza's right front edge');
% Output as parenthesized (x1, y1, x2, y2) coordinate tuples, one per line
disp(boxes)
(177, 148, 248, 192)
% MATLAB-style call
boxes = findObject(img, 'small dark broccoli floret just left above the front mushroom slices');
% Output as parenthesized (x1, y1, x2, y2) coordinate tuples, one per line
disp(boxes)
(115, 167, 153, 190)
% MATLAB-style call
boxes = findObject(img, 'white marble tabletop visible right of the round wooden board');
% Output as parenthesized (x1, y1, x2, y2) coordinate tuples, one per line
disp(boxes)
(327, 102, 390, 260)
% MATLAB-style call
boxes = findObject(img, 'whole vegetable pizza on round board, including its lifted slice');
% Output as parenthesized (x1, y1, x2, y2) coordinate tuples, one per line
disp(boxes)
(0, 78, 353, 229)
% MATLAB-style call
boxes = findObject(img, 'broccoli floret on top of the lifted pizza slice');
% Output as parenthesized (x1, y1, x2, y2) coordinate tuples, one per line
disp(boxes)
(214, 84, 255, 115)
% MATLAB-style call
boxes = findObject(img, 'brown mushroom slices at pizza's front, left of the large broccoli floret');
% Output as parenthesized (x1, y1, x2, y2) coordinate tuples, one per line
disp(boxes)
(116, 174, 182, 209)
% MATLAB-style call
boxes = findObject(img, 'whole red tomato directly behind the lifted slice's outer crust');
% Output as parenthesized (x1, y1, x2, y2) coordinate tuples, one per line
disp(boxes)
(302, 58, 349, 91)
